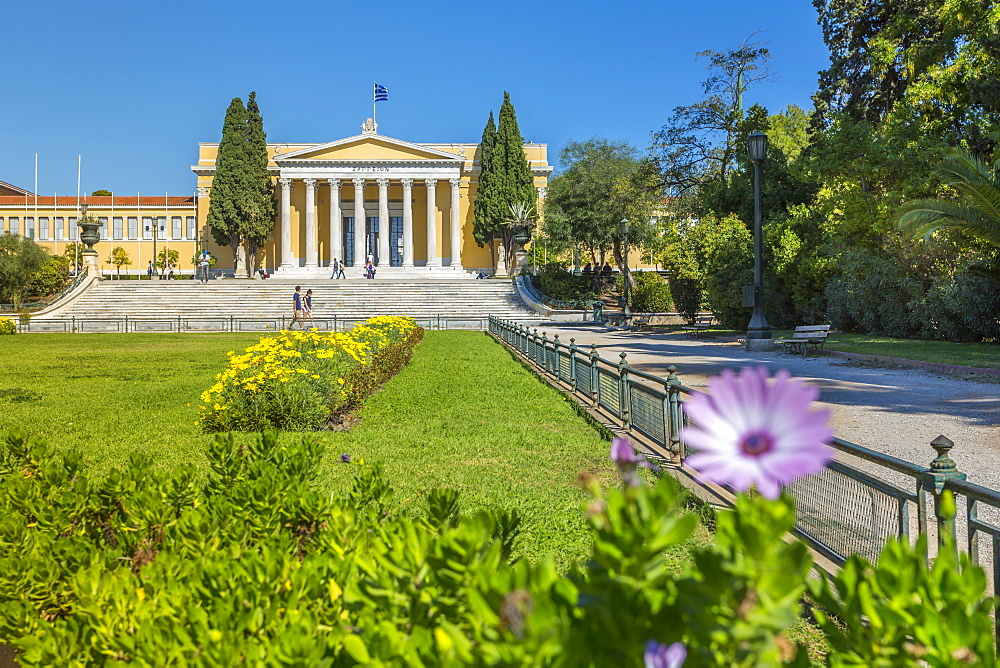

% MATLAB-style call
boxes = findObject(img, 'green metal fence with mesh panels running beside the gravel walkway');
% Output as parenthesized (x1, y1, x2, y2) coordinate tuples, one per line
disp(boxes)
(489, 318, 1000, 638)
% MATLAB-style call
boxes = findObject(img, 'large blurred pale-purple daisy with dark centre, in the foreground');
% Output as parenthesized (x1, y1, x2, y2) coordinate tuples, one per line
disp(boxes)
(681, 367, 833, 499)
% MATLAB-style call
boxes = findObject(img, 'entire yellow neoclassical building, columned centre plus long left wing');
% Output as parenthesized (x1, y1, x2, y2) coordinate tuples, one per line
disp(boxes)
(0, 119, 552, 278)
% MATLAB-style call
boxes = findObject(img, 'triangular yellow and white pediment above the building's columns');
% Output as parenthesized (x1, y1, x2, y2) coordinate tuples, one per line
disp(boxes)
(274, 134, 465, 165)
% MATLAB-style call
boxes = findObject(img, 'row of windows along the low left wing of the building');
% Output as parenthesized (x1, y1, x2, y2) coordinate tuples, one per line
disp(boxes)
(0, 216, 197, 241)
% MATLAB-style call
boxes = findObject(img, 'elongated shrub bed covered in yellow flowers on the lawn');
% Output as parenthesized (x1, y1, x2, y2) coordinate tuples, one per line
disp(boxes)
(198, 316, 423, 432)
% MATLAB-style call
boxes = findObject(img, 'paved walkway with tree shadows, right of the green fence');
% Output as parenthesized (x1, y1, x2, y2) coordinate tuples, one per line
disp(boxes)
(539, 325, 1000, 489)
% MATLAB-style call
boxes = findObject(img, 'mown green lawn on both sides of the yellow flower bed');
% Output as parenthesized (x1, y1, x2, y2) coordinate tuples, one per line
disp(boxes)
(0, 331, 708, 568)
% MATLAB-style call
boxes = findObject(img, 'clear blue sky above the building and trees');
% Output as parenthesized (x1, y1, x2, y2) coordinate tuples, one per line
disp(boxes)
(0, 0, 828, 195)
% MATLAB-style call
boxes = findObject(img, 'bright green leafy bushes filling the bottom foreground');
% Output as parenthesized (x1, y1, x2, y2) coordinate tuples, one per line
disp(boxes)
(0, 432, 995, 667)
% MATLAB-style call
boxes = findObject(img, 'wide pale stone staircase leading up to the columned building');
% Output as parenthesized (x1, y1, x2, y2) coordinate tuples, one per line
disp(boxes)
(31, 279, 538, 331)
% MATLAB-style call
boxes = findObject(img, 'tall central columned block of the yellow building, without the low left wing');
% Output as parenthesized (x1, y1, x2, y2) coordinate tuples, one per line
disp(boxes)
(191, 119, 552, 277)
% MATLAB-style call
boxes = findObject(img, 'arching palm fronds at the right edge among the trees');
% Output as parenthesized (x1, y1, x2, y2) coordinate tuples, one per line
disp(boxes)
(899, 149, 1000, 283)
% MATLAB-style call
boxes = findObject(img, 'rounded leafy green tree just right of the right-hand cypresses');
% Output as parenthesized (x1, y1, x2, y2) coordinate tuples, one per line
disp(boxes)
(545, 138, 663, 292)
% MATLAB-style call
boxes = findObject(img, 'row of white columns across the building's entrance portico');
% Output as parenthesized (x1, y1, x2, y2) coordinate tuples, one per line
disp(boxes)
(278, 177, 462, 268)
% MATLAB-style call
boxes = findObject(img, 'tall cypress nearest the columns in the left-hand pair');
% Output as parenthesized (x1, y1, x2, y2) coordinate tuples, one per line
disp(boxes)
(241, 92, 277, 271)
